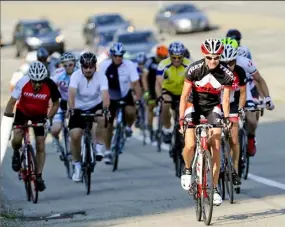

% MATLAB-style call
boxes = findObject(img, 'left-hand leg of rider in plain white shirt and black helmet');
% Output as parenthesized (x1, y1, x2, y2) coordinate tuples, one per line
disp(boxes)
(68, 111, 86, 182)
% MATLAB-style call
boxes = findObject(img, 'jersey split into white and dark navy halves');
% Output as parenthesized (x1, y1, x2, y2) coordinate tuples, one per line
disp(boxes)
(99, 59, 139, 100)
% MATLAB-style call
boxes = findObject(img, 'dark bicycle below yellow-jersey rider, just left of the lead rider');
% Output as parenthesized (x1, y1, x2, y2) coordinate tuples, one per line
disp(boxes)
(169, 100, 185, 178)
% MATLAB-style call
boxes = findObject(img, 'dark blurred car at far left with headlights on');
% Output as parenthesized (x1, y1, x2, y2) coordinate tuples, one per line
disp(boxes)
(12, 19, 65, 57)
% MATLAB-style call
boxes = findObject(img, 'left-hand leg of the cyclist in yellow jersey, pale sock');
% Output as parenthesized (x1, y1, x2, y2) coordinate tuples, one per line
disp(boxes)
(161, 89, 172, 143)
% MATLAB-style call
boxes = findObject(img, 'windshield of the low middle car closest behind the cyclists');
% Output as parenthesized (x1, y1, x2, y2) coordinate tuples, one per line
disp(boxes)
(118, 32, 156, 44)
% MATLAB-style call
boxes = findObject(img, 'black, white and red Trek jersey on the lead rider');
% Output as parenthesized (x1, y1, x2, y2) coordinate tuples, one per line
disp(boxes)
(186, 59, 234, 112)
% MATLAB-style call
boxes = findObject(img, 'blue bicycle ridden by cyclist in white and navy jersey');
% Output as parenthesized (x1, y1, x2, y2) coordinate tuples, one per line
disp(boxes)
(111, 100, 126, 172)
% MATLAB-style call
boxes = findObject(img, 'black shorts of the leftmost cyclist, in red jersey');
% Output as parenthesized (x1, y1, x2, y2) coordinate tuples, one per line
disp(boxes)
(13, 109, 47, 137)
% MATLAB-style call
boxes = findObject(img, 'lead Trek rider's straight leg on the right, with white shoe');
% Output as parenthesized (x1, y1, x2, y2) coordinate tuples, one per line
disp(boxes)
(203, 105, 223, 205)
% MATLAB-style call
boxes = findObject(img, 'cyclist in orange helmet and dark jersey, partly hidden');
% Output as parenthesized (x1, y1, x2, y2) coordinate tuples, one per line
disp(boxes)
(142, 45, 168, 141)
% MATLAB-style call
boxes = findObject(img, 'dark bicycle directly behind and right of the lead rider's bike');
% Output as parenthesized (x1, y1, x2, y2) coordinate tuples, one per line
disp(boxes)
(218, 127, 234, 204)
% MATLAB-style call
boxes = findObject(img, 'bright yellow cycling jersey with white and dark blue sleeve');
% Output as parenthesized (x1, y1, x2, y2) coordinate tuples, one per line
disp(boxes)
(157, 57, 191, 95)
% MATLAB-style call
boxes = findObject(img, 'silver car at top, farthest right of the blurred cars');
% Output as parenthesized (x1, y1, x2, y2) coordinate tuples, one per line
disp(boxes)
(154, 3, 210, 35)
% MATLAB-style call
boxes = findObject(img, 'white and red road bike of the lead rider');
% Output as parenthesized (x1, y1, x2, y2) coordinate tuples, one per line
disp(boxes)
(184, 118, 223, 225)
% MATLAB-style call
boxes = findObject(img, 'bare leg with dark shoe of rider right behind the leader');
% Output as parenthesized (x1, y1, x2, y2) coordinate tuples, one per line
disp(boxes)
(226, 102, 240, 185)
